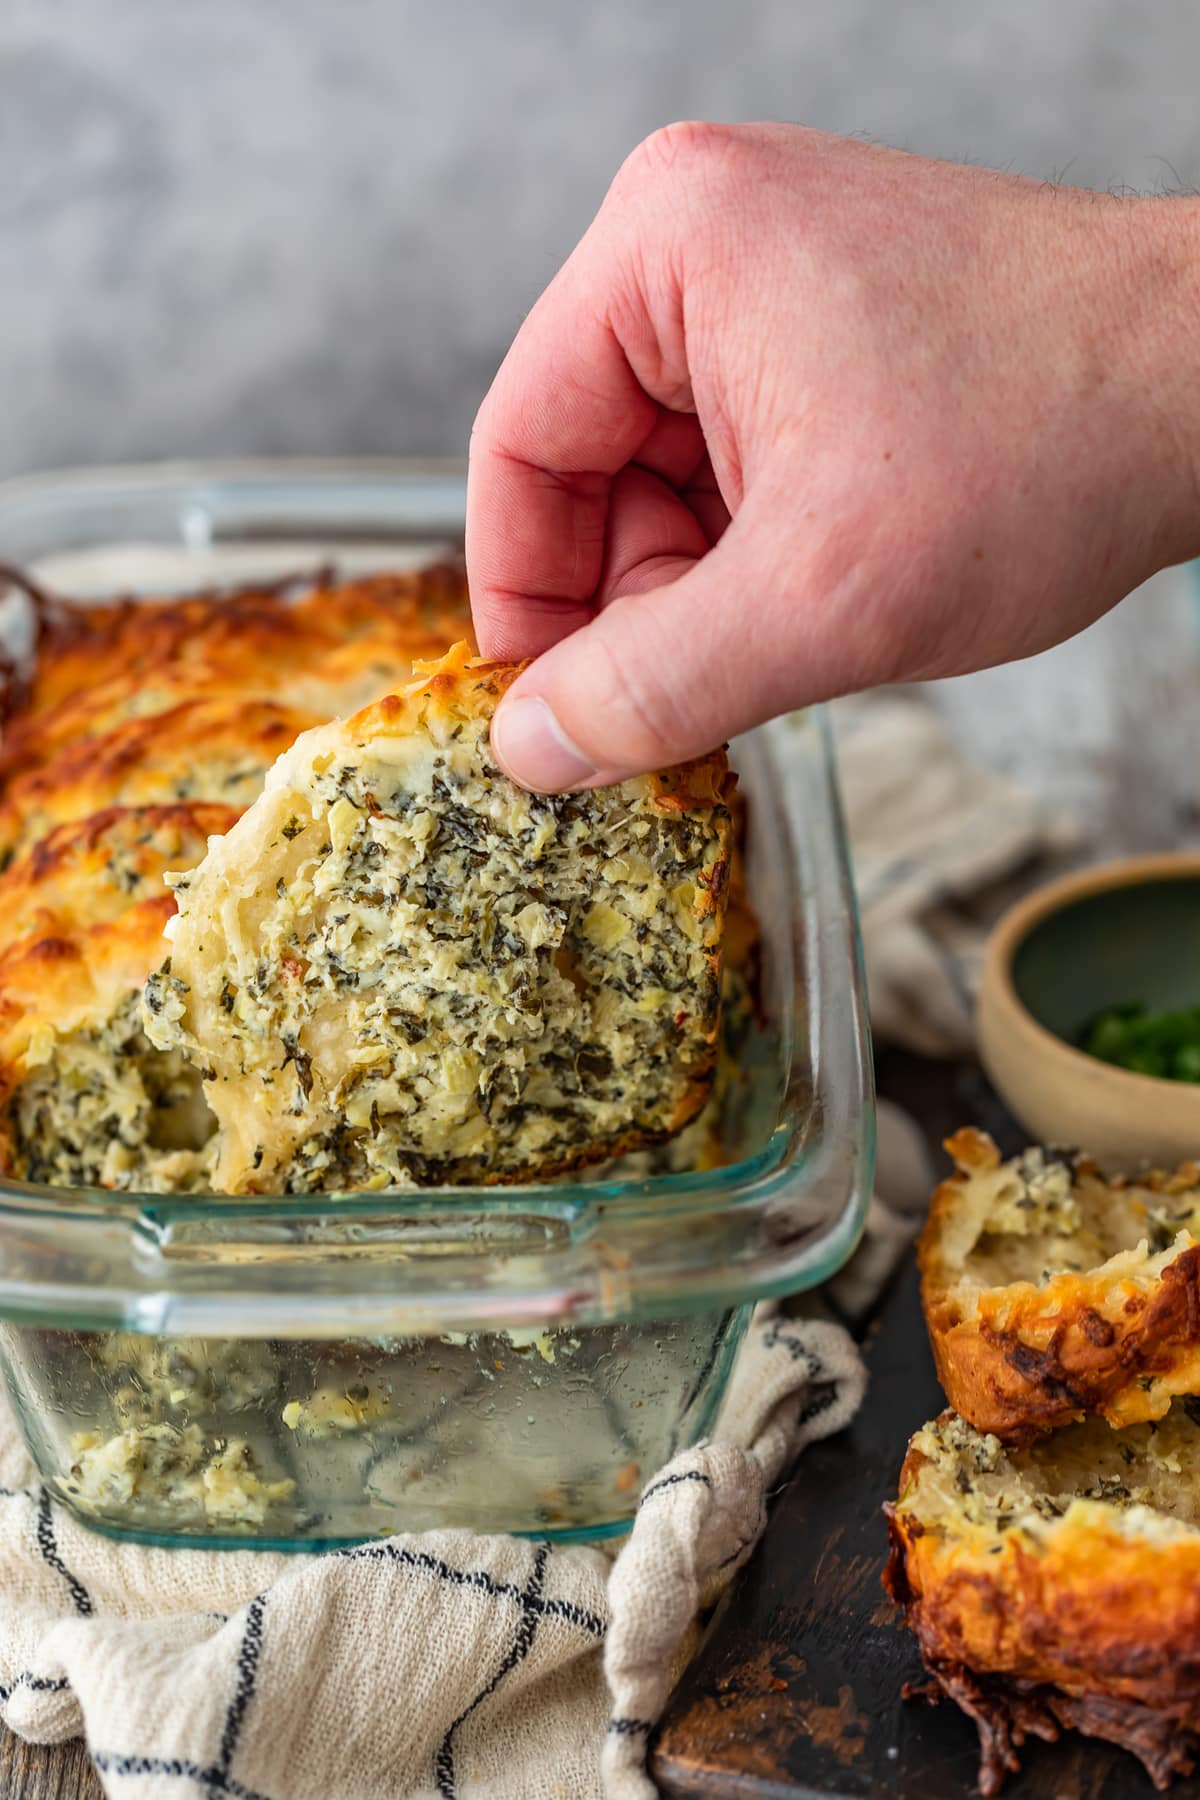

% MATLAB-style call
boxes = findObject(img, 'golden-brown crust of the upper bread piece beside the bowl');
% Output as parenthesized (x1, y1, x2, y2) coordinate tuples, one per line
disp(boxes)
(918, 1129, 1200, 1442)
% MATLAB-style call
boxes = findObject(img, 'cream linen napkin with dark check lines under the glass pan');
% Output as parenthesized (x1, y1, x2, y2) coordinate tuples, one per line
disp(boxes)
(0, 697, 1049, 1800)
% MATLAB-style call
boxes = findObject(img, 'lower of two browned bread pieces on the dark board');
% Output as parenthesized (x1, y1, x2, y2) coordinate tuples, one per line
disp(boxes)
(887, 1400, 1200, 1795)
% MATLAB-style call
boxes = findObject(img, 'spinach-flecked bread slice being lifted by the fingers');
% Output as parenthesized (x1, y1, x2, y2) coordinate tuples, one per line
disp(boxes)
(146, 644, 732, 1192)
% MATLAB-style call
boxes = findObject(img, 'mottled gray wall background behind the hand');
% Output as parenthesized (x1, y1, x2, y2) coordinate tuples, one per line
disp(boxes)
(0, 0, 1200, 473)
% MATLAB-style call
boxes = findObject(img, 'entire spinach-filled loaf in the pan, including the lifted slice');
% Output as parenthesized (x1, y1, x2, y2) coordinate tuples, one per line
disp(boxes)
(0, 565, 744, 1193)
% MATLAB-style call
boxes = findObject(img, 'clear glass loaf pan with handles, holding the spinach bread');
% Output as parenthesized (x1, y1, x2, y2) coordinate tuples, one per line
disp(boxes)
(0, 463, 873, 1550)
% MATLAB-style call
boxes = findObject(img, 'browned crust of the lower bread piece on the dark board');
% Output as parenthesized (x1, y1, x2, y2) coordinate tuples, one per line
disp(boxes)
(885, 1413, 1200, 1795)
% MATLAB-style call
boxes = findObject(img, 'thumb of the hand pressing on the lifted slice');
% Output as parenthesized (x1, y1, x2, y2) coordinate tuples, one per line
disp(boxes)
(491, 506, 838, 794)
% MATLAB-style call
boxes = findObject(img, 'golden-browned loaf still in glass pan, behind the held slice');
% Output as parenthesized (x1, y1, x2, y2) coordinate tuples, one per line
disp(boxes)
(0, 565, 468, 1193)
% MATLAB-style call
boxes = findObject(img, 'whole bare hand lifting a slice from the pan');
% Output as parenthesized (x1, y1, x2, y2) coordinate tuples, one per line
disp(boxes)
(466, 124, 1200, 790)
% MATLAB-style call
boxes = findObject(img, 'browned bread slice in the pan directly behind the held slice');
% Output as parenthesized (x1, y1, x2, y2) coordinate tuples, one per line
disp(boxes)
(0, 805, 237, 1192)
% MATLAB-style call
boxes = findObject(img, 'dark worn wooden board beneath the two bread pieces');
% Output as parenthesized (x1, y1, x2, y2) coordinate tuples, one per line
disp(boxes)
(651, 1058, 1200, 1800)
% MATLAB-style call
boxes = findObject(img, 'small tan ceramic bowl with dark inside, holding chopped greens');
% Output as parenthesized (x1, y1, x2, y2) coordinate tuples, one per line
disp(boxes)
(979, 853, 1200, 1174)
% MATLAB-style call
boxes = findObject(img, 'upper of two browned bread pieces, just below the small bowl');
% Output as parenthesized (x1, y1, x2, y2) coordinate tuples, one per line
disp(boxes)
(919, 1130, 1200, 1440)
